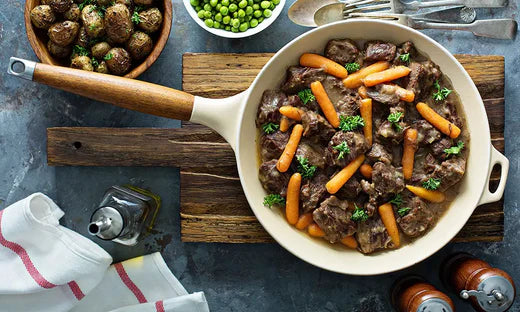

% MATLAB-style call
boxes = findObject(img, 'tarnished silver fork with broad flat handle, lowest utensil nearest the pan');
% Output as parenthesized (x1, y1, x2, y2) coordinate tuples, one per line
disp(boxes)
(348, 12, 518, 39)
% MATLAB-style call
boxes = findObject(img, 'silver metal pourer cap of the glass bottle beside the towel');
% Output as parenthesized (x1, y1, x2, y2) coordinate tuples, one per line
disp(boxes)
(88, 206, 124, 240)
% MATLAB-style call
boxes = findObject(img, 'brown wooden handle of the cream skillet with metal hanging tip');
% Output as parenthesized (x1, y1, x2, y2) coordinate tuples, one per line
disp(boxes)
(8, 57, 195, 120)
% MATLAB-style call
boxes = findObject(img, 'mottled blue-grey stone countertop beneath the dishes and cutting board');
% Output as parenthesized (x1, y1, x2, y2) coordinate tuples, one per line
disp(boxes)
(0, 0, 520, 312)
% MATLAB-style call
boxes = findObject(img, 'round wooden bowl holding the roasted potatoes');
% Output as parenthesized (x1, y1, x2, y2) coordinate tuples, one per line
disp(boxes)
(24, 0, 172, 78)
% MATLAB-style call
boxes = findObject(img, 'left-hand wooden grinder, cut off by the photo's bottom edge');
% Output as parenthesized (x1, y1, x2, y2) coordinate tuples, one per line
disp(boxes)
(390, 275, 455, 312)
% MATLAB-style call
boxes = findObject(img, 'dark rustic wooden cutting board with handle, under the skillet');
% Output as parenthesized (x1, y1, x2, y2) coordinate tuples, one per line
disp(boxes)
(47, 53, 504, 243)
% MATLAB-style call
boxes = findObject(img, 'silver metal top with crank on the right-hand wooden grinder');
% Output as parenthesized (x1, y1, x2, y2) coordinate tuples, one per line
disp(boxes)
(460, 275, 515, 312)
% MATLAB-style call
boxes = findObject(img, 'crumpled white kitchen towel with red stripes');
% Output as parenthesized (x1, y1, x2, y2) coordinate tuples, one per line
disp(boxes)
(0, 193, 209, 312)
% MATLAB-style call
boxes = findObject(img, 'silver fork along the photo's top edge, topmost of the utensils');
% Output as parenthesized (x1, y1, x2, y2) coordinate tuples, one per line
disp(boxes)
(341, 0, 508, 14)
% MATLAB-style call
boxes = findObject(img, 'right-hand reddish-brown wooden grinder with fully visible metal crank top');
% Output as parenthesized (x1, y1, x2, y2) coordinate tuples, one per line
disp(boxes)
(441, 253, 516, 312)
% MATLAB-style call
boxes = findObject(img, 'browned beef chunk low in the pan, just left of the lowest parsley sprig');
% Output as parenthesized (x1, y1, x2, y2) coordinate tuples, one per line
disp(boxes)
(312, 195, 356, 243)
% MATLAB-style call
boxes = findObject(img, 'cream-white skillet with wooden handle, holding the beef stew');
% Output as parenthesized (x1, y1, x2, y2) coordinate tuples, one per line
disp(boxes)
(9, 20, 509, 275)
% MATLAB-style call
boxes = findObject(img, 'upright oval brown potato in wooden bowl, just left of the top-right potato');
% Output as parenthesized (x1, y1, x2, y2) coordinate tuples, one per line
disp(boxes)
(105, 4, 134, 43)
